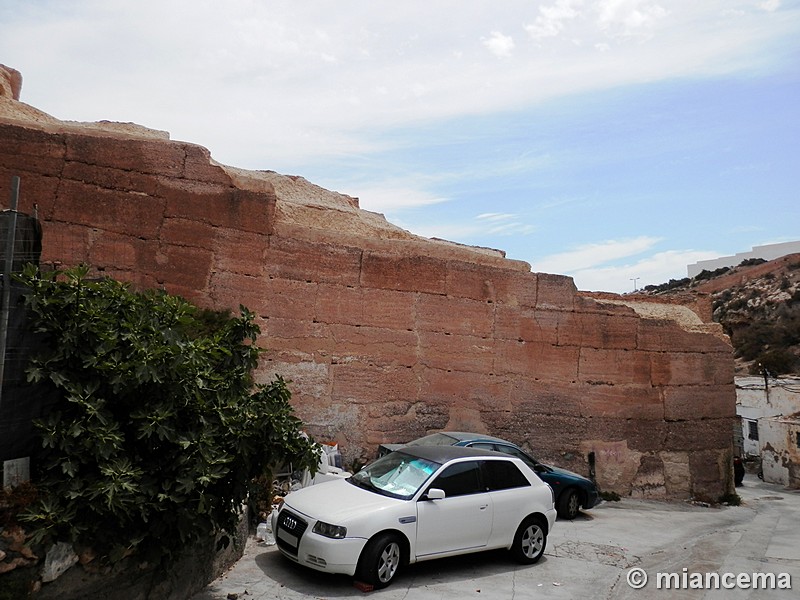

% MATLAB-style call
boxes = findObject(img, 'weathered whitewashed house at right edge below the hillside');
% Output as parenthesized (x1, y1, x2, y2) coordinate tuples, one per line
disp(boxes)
(736, 377, 800, 488)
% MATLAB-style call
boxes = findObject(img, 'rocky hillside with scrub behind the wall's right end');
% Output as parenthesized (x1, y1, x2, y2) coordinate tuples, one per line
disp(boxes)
(643, 254, 800, 375)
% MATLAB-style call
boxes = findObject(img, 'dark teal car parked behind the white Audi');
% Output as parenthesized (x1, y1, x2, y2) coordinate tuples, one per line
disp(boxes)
(378, 431, 601, 519)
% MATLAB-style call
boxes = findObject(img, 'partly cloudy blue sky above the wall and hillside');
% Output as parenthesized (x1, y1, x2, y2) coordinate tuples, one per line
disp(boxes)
(0, 0, 800, 292)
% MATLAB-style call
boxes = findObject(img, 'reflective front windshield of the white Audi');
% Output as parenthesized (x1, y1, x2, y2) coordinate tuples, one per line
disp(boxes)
(347, 452, 441, 500)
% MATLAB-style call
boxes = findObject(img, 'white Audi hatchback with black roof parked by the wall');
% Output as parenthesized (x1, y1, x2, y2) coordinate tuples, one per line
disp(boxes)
(272, 446, 556, 588)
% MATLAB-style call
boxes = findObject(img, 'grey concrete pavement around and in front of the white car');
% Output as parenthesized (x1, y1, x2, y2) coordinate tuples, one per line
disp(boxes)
(193, 475, 800, 600)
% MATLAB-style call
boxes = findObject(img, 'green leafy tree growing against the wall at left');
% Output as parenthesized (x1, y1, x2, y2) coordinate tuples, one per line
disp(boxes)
(15, 267, 318, 562)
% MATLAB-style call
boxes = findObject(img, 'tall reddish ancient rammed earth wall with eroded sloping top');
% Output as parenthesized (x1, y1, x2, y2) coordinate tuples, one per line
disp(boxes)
(0, 69, 735, 498)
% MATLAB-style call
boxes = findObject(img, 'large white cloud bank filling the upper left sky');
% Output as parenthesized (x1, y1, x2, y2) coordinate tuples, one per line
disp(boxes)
(0, 0, 797, 169)
